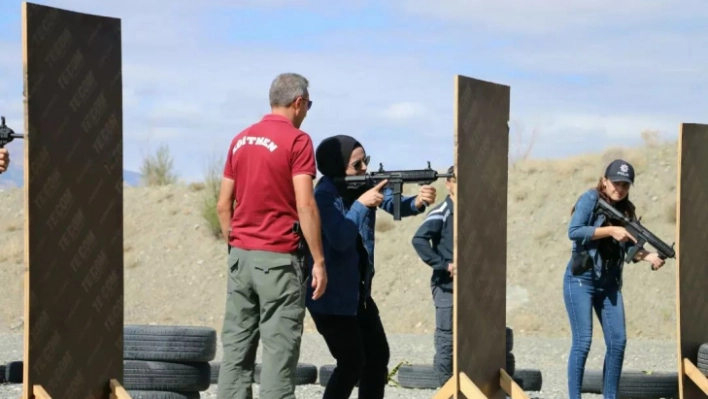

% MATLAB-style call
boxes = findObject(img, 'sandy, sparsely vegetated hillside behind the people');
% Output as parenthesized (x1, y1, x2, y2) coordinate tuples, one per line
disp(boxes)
(0, 138, 677, 338)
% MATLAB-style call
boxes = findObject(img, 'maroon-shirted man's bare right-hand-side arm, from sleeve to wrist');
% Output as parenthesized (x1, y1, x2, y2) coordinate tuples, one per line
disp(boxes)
(293, 174, 324, 264)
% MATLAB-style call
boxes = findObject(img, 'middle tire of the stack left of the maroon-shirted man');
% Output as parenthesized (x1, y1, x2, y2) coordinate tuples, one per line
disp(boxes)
(123, 360, 211, 392)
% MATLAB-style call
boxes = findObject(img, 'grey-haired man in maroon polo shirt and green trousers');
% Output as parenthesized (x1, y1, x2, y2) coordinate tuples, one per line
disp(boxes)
(217, 73, 327, 399)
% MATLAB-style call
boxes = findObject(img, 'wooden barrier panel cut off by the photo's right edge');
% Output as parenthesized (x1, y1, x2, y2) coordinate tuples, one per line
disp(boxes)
(676, 123, 708, 399)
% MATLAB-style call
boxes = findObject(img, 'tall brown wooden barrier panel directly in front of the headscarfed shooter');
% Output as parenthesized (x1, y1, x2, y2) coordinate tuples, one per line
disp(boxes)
(433, 75, 527, 399)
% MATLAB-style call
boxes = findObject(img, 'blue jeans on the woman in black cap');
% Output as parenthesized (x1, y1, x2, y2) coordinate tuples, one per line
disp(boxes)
(563, 268, 627, 399)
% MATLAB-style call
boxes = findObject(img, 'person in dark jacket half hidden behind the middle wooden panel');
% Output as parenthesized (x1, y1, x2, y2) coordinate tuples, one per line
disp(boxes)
(412, 166, 457, 386)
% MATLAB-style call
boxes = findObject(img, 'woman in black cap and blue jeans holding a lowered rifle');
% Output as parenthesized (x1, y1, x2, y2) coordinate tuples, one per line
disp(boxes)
(563, 159, 664, 399)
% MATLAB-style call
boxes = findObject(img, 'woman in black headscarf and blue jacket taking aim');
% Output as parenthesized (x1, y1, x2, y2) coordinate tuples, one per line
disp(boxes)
(306, 135, 435, 399)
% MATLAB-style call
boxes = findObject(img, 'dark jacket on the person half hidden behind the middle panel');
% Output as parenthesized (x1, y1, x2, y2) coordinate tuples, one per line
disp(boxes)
(412, 195, 454, 289)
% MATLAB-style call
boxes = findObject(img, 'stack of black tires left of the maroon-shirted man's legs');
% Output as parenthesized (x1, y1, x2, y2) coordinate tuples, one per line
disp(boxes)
(123, 325, 217, 399)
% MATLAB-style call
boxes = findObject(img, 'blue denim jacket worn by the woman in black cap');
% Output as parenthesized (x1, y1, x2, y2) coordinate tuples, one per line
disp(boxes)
(568, 188, 636, 278)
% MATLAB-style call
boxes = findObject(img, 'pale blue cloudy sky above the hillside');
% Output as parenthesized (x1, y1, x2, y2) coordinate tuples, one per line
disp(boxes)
(0, 0, 708, 180)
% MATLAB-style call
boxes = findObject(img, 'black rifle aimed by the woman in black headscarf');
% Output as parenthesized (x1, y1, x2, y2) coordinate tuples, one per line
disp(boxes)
(337, 161, 455, 220)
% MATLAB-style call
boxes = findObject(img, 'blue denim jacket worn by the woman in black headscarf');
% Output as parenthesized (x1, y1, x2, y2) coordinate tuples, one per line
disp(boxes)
(306, 176, 425, 316)
